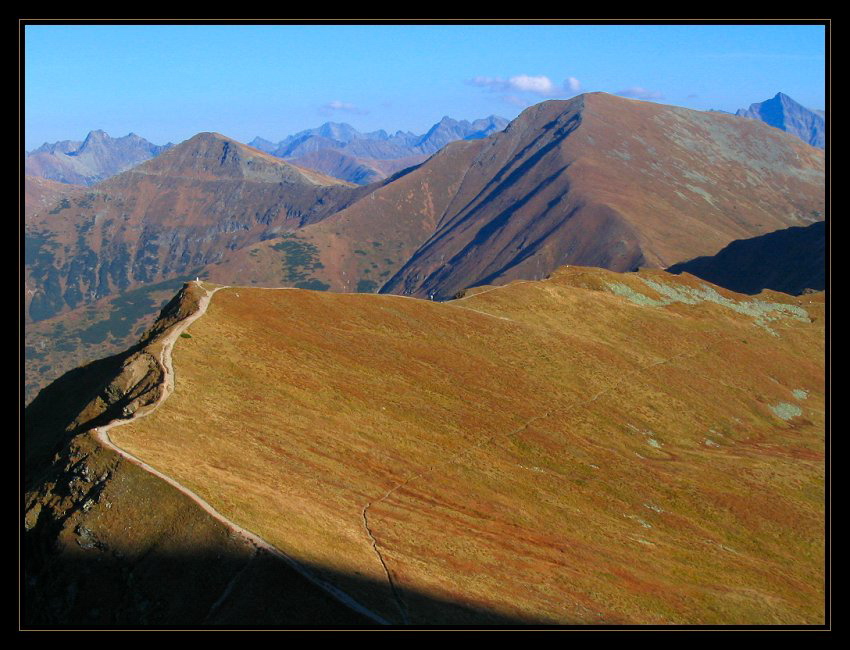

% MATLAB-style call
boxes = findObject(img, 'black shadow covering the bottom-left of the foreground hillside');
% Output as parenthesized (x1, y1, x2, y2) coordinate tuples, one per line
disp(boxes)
(21, 540, 548, 629)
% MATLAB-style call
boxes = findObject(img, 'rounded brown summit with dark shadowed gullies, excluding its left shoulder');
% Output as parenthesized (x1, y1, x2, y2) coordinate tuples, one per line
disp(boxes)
(381, 93, 824, 298)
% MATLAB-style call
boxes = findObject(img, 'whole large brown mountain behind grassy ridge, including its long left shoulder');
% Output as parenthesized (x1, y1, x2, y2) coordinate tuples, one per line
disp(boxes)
(206, 93, 824, 299)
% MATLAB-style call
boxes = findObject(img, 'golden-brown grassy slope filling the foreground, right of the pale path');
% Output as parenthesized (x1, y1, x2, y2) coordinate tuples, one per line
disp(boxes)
(106, 267, 825, 625)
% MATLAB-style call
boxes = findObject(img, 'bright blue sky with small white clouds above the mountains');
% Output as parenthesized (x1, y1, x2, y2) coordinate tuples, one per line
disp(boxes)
(24, 24, 825, 150)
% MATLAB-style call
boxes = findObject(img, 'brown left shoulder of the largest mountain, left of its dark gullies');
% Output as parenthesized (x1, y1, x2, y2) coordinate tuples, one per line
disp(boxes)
(204, 140, 485, 293)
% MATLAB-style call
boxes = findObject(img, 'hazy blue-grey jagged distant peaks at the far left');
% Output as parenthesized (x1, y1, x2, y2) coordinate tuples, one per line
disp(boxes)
(25, 131, 173, 185)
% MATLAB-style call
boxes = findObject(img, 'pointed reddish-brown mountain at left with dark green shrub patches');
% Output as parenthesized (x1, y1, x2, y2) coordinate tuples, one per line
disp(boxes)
(26, 133, 361, 320)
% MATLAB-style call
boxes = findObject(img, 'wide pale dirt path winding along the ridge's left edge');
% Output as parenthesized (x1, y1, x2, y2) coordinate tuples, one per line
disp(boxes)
(94, 283, 390, 625)
